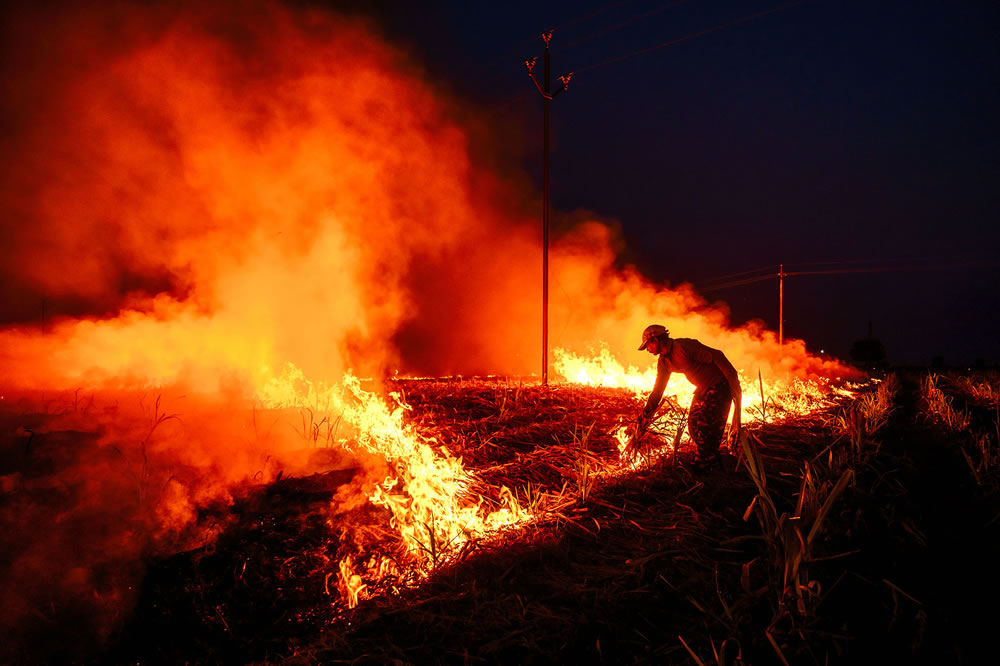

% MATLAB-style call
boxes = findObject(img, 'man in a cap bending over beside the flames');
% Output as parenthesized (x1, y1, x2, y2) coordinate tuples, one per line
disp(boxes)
(633, 324, 743, 466)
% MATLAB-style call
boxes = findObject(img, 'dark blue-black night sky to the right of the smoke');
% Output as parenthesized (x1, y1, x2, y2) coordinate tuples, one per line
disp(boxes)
(340, 0, 1000, 363)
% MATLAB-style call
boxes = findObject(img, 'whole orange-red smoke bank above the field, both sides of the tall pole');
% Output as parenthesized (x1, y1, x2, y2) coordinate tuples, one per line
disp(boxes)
(0, 3, 844, 390)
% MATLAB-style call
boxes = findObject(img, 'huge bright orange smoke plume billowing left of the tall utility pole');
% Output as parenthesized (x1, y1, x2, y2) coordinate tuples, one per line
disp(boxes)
(0, 0, 532, 390)
